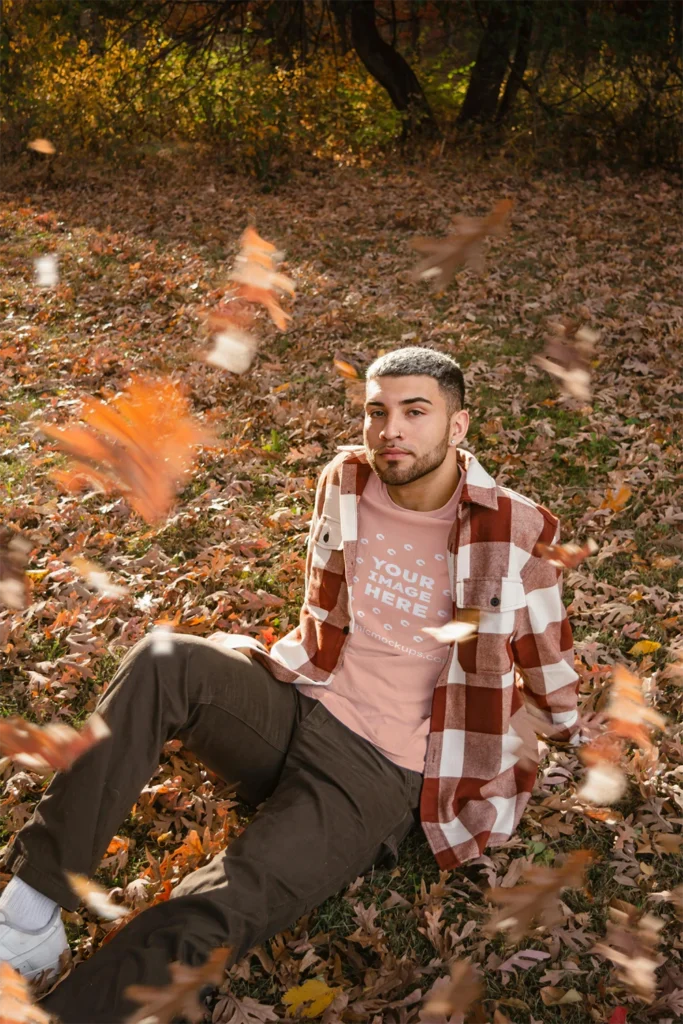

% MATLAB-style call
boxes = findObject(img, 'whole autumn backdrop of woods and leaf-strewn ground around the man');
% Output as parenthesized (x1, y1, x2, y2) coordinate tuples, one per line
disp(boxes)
(0, 0, 683, 1024)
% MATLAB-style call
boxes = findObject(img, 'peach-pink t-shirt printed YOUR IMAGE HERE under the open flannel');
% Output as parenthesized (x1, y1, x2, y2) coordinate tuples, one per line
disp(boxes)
(299, 473, 465, 772)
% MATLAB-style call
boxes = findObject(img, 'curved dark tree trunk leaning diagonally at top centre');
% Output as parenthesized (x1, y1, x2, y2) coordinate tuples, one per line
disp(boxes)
(349, 0, 438, 135)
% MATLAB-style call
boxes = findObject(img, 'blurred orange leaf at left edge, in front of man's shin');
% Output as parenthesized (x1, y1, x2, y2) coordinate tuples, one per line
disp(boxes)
(0, 713, 111, 772)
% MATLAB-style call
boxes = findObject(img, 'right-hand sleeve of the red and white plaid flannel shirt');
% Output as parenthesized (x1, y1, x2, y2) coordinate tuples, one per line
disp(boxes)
(512, 520, 579, 741)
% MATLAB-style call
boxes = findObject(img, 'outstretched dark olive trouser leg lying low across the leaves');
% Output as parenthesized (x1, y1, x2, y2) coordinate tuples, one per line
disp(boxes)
(44, 703, 422, 1024)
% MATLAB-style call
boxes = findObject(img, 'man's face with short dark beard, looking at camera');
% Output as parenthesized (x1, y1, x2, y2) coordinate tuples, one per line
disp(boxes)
(362, 376, 461, 486)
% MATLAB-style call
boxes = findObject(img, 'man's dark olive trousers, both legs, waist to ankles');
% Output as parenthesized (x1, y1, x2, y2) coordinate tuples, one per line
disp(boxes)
(9, 635, 422, 1024)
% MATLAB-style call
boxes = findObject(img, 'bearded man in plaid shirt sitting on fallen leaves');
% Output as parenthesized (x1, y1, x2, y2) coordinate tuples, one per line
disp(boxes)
(0, 347, 578, 1024)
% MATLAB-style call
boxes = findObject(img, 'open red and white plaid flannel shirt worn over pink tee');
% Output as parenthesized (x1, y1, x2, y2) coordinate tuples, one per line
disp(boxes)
(225, 445, 579, 868)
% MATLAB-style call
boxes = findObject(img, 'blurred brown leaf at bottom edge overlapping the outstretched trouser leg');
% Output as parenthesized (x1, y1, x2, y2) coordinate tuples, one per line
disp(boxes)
(124, 947, 230, 1024)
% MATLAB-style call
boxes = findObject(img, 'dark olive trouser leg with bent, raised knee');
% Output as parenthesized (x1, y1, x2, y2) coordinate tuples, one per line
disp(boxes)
(8, 635, 307, 910)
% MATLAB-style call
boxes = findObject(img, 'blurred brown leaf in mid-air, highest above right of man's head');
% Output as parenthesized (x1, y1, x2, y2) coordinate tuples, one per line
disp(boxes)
(411, 199, 513, 291)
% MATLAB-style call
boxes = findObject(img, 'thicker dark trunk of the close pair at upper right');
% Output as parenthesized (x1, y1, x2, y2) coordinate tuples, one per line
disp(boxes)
(458, 0, 516, 124)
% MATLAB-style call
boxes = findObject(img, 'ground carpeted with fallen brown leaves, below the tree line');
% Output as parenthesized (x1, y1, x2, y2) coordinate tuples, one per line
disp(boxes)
(0, 159, 683, 1024)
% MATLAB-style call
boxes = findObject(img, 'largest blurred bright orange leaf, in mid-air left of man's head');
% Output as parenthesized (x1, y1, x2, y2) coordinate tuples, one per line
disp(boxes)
(40, 378, 211, 522)
